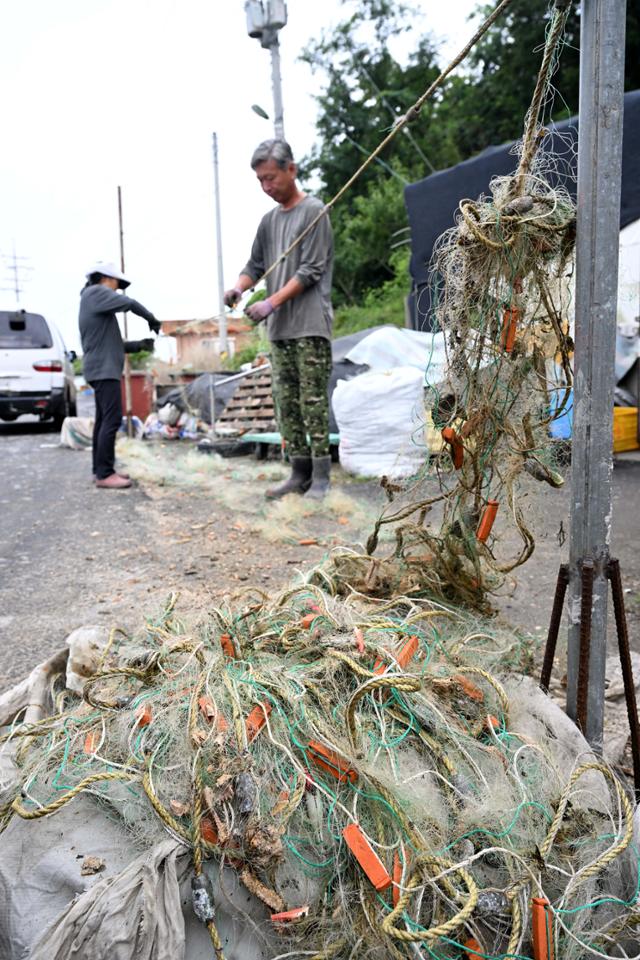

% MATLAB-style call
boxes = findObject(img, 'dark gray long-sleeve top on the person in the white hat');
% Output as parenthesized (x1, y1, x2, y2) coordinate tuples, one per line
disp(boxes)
(79, 283, 154, 383)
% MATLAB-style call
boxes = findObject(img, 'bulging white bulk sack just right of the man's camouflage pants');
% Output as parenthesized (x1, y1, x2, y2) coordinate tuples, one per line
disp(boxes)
(332, 367, 427, 477)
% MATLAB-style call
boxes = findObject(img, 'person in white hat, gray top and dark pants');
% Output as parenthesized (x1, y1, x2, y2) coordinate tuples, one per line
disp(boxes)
(79, 263, 160, 490)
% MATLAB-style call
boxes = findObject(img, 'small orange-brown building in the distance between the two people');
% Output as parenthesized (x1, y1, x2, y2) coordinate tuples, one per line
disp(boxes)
(162, 317, 253, 370)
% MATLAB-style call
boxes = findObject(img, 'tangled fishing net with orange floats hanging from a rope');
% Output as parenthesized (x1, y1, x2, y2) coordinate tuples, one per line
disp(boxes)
(333, 4, 575, 612)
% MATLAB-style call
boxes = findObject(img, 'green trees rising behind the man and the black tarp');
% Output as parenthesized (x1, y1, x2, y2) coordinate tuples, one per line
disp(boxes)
(302, 0, 640, 316)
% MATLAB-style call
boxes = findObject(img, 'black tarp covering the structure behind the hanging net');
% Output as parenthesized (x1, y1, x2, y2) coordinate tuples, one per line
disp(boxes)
(404, 90, 640, 330)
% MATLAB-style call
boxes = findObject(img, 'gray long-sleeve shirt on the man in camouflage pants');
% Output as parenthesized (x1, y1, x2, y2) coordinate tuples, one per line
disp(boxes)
(242, 197, 333, 340)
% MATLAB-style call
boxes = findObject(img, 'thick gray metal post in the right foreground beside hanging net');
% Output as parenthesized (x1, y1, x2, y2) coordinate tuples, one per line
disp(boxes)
(567, 0, 626, 751)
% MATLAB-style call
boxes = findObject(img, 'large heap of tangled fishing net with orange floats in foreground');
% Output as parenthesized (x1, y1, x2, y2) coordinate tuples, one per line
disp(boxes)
(2, 585, 638, 960)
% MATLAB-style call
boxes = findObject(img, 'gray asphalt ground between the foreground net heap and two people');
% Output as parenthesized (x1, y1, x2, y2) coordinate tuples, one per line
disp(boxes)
(0, 402, 640, 691)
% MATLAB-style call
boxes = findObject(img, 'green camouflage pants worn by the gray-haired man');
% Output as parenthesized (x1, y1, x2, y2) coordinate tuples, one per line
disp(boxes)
(271, 337, 331, 457)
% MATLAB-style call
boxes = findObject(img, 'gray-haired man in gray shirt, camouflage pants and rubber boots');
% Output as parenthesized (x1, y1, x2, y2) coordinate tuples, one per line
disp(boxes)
(224, 140, 333, 499)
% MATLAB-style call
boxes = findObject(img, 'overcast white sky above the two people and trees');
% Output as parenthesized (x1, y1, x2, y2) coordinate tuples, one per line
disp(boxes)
(0, 0, 476, 349)
